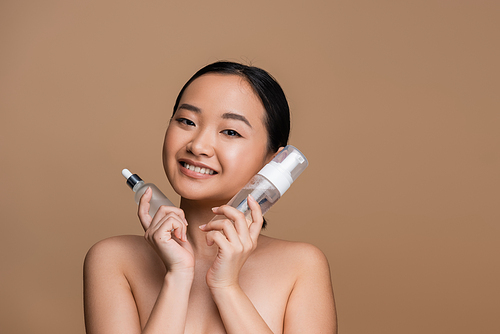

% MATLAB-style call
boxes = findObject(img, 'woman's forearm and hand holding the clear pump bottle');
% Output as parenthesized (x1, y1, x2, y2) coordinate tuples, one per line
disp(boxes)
(200, 196, 272, 334)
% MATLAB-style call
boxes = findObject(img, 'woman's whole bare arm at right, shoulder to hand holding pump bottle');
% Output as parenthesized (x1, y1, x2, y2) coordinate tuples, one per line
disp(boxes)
(201, 197, 337, 334)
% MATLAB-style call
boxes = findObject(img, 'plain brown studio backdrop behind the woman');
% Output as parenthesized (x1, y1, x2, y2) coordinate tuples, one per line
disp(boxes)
(0, 0, 500, 334)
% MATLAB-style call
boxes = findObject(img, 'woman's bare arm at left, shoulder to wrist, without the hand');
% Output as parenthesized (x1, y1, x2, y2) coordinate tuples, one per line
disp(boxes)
(84, 237, 193, 334)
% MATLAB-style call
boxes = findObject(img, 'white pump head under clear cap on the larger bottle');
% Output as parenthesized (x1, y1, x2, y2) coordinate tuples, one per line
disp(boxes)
(258, 145, 308, 196)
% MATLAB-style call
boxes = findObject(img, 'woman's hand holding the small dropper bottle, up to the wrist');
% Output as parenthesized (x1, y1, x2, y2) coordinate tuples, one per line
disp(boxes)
(137, 188, 194, 273)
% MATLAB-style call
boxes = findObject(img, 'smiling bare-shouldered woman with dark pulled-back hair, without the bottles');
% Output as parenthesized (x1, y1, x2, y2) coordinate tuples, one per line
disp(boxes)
(84, 62, 336, 334)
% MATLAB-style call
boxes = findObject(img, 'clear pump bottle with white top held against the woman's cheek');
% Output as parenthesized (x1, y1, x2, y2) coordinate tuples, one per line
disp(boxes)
(224, 145, 308, 221)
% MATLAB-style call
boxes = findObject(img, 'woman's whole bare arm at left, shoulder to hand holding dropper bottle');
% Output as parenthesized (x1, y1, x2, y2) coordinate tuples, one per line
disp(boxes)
(84, 189, 194, 334)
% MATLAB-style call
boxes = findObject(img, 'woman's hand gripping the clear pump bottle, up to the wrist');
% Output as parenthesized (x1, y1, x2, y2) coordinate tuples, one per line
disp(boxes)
(200, 195, 263, 288)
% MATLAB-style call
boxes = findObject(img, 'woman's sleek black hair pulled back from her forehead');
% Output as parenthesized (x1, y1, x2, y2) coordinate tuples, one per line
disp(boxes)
(172, 61, 290, 152)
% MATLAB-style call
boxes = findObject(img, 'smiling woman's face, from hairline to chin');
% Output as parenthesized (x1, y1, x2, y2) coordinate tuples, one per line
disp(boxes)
(163, 74, 273, 201)
